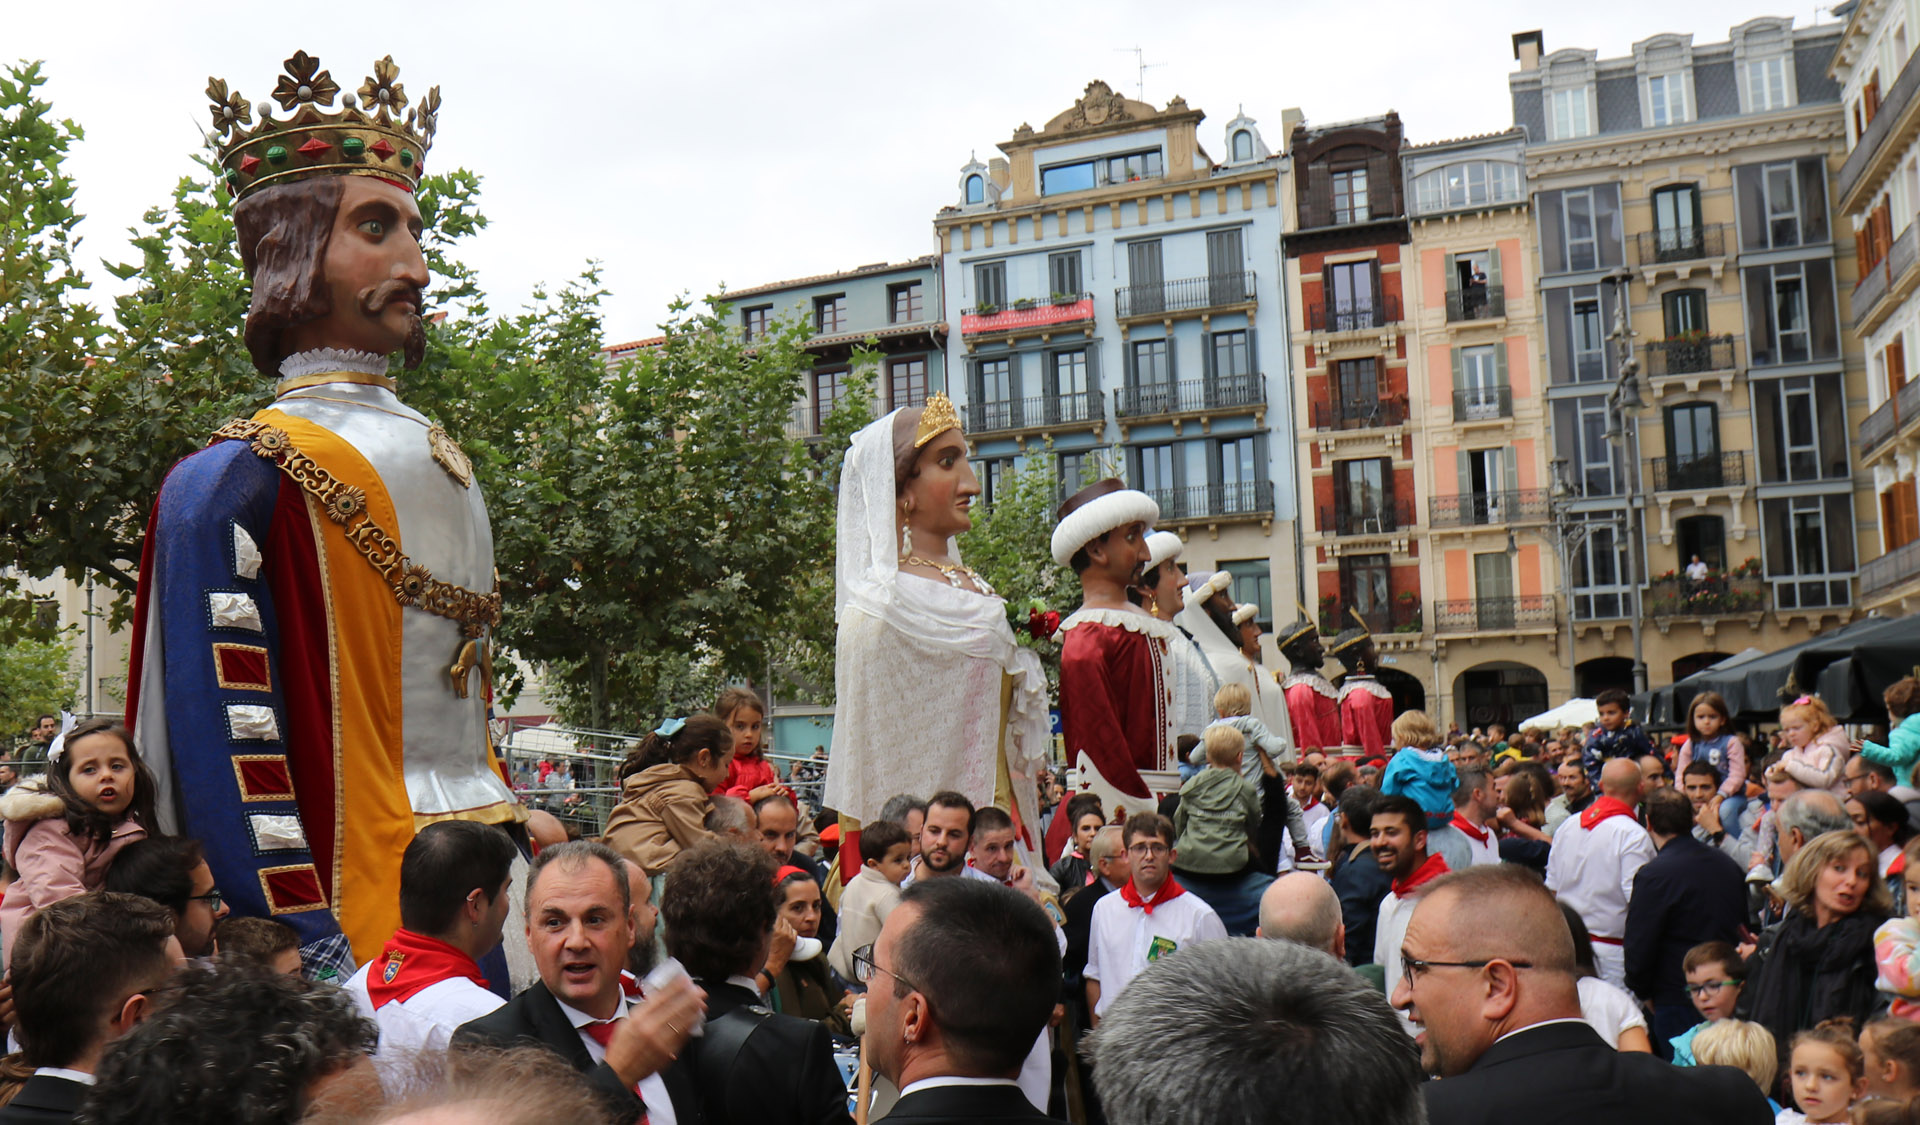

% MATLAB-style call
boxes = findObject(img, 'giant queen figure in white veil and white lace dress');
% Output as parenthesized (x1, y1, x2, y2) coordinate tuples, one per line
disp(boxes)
(824, 394, 1050, 840)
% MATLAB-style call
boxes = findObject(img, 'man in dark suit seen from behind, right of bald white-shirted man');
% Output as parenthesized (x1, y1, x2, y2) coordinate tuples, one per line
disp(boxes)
(1626, 779, 1747, 1058)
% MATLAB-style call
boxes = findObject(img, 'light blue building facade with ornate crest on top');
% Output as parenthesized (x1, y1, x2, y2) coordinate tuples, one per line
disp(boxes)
(933, 81, 1298, 658)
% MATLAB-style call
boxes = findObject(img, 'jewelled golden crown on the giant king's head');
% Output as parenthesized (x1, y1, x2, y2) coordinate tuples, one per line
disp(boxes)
(207, 50, 440, 200)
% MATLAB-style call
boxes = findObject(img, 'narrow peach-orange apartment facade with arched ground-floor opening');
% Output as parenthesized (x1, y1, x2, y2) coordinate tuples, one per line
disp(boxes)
(1400, 129, 1572, 728)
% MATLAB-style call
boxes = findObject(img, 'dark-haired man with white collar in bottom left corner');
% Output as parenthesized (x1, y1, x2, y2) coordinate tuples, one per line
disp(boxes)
(0, 891, 182, 1125)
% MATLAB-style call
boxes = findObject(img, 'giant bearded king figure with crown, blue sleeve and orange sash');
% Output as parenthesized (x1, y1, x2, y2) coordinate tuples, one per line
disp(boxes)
(127, 52, 526, 975)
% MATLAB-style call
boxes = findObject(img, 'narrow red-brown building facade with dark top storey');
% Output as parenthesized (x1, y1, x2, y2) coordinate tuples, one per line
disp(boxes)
(1284, 113, 1434, 710)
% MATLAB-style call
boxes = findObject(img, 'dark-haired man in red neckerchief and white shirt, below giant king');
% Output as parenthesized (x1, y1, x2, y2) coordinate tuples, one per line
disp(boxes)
(346, 820, 518, 1065)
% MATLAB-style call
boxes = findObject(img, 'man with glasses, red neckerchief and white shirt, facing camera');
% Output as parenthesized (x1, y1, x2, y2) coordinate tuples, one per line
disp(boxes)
(1081, 812, 1227, 1027)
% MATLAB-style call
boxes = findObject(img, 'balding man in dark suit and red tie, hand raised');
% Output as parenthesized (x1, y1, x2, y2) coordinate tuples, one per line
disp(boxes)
(453, 841, 705, 1125)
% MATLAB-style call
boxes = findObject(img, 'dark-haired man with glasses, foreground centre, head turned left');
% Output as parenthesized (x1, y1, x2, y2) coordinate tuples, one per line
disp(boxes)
(854, 879, 1060, 1125)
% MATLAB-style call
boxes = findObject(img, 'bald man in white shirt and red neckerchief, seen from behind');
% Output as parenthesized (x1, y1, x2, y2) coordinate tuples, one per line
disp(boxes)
(1548, 758, 1655, 989)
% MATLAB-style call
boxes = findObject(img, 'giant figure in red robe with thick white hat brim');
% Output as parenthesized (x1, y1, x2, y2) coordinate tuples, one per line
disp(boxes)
(1052, 478, 1175, 816)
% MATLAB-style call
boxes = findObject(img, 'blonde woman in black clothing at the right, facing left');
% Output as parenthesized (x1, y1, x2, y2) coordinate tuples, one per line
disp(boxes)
(1741, 831, 1893, 1073)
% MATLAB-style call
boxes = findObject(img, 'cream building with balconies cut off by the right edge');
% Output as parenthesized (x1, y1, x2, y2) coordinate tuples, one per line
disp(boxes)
(1832, 0, 1920, 614)
